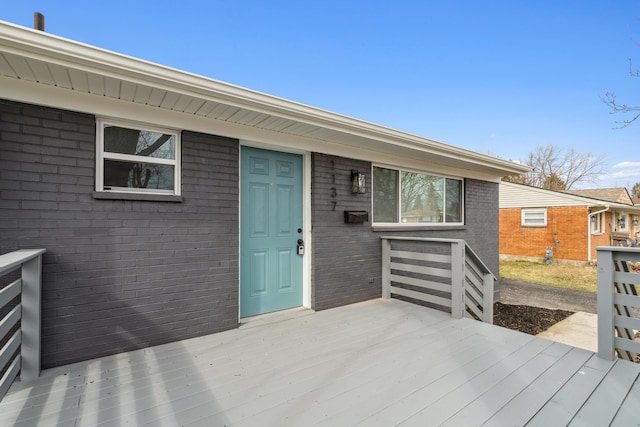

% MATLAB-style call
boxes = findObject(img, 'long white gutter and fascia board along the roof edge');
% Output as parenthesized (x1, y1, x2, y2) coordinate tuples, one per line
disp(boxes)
(0, 21, 529, 180)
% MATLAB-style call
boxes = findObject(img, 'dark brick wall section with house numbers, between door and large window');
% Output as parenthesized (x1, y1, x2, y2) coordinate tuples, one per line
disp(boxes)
(312, 153, 381, 310)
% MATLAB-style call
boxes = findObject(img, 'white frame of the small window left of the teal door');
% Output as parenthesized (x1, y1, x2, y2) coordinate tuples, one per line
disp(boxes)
(96, 118, 182, 196)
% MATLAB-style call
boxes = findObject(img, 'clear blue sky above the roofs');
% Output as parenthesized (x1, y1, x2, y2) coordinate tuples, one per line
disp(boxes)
(0, 0, 640, 191)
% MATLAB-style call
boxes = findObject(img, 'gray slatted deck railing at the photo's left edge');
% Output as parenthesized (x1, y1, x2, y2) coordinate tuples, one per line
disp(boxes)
(0, 249, 45, 399)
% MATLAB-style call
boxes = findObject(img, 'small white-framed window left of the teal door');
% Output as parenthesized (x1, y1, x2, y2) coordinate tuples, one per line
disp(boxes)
(96, 120, 180, 195)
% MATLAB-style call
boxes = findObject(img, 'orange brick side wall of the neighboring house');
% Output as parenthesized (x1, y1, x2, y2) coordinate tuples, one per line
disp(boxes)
(500, 206, 592, 261)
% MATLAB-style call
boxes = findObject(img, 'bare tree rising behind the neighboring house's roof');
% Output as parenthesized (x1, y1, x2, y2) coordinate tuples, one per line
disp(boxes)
(505, 144, 604, 190)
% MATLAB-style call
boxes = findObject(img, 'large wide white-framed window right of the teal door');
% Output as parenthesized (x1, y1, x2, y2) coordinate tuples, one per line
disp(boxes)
(372, 166, 464, 225)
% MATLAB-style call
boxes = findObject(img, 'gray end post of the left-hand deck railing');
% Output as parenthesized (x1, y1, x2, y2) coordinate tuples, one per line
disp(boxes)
(20, 255, 42, 381)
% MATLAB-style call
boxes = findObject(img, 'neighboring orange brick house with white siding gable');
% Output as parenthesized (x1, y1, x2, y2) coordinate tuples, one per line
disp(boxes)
(500, 182, 640, 262)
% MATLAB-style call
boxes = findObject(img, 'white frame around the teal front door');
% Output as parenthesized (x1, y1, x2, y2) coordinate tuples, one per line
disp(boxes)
(238, 140, 313, 320)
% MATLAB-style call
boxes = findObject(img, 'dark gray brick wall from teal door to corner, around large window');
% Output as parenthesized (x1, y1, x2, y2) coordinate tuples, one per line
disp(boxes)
(312, 153, 498, 310)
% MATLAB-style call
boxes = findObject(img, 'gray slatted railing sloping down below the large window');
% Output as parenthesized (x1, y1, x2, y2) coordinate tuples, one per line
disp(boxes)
(382, 236, 496, 323)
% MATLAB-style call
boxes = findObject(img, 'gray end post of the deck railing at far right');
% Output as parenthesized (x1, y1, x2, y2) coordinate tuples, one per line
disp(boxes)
(596, 248, 615, 360)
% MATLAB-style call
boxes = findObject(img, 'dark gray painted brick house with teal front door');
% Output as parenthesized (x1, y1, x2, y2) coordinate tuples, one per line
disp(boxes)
(0, 22, 527, 367)
